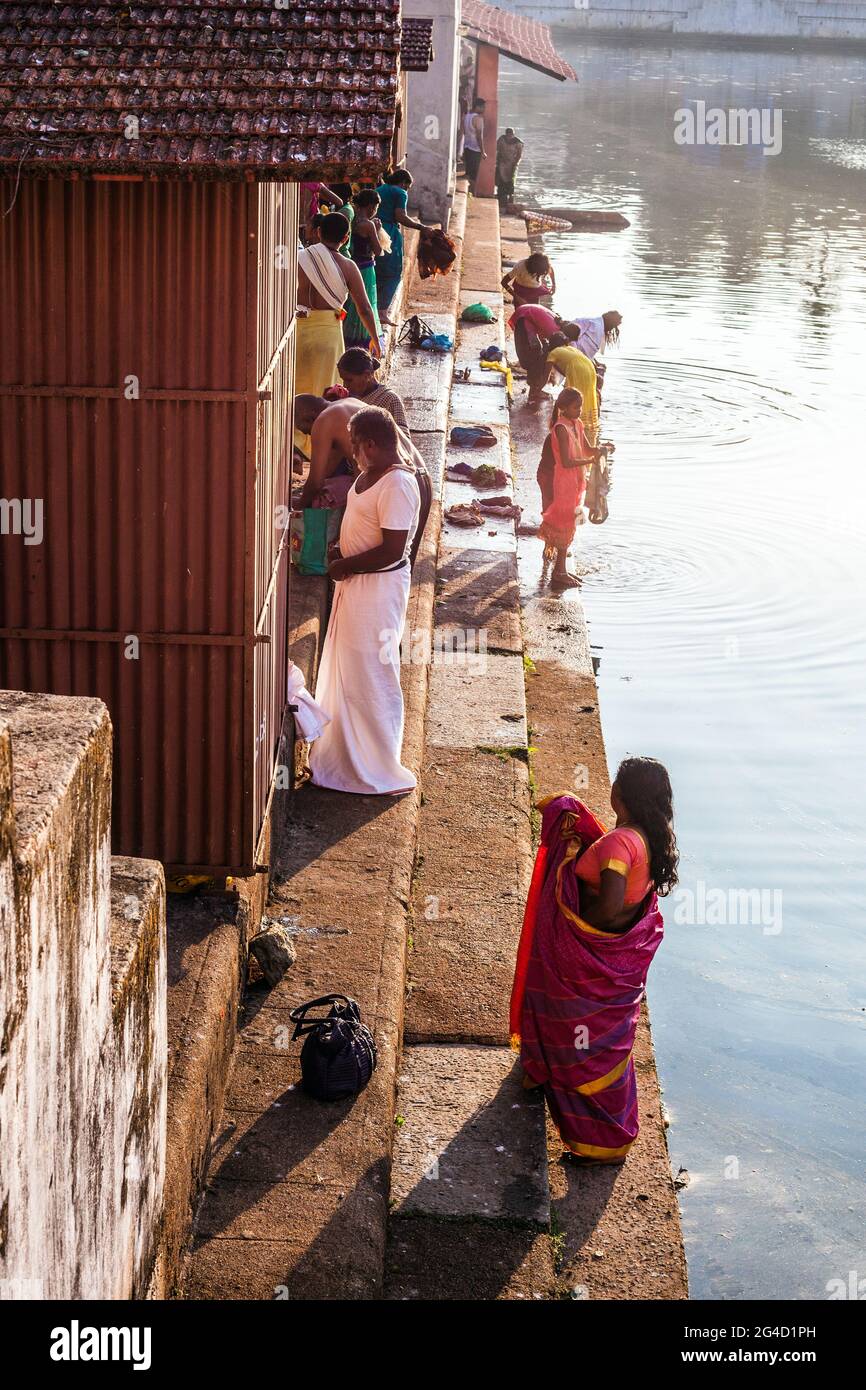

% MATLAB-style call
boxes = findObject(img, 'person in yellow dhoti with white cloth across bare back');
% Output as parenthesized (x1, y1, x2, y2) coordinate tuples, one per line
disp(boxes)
(295, 213, 379, 396)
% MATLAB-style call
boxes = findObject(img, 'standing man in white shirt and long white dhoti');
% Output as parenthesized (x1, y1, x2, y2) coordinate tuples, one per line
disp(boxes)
(310, 406, 420, 796)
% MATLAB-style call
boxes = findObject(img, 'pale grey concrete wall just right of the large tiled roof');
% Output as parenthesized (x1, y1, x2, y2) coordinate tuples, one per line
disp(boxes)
(403, 0, 460, 225)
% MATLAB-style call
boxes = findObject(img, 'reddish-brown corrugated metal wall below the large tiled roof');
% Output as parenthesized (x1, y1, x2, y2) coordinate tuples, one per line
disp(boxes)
(0, 170, 295, 872)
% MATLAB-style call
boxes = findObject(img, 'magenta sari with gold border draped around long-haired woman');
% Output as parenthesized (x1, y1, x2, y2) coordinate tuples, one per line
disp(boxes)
(510, 792, 664, 1163)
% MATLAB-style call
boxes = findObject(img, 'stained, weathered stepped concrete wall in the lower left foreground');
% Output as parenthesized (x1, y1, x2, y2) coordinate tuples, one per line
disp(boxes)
(0, 691, 167, 1298)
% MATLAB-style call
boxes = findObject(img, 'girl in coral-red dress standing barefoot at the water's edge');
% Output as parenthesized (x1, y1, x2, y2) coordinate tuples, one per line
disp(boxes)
(537, 386, 601, 589)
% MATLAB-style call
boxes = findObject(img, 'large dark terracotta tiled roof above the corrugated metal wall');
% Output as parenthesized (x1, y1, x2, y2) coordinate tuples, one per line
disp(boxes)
(0, 0, 400, 179)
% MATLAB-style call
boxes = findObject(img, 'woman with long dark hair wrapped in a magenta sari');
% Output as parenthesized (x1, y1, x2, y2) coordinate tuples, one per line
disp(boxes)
(510, 758, 678, 1163)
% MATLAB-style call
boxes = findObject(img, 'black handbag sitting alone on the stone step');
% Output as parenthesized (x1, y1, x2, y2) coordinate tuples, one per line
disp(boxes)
(289, 994, 377, 1101)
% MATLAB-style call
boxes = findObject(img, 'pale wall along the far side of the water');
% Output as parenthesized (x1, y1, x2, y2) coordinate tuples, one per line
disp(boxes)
(500, 0, 866, 43)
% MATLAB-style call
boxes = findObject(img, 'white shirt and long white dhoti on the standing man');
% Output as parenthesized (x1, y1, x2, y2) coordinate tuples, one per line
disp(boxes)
(310, 471, 418, 795)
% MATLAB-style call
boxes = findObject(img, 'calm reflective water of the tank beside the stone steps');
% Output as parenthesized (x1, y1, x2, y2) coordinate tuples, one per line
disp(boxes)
(499, 32, 866, 1298)
